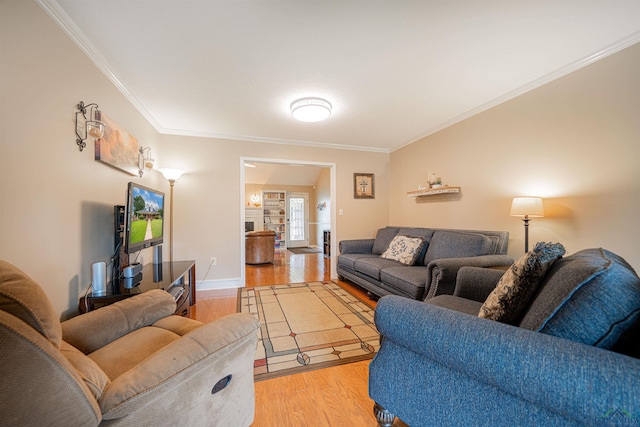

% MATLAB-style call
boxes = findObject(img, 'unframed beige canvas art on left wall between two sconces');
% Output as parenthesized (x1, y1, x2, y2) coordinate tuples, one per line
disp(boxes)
(96, 113, 139, 175)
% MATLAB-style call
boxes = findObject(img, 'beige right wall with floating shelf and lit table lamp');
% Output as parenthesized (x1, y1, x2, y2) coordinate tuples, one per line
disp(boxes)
(390, 44, 640, 270)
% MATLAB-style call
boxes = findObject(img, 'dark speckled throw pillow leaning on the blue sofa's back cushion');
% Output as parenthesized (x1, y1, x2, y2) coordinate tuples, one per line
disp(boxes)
(478, 242, 565, 323)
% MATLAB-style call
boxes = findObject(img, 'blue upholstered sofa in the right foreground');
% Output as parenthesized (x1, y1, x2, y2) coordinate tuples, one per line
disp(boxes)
(369, 249, 640, 427)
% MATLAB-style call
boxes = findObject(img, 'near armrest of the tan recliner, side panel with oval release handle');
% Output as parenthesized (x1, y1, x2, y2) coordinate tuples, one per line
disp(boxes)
(99, 313, 259, 425)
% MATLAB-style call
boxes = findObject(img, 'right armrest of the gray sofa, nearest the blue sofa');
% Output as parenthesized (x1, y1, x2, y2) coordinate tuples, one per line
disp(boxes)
(425, 255, 513, 299)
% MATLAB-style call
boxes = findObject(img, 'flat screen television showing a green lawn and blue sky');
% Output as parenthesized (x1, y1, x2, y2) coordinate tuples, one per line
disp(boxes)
(124, 182, 164, 254)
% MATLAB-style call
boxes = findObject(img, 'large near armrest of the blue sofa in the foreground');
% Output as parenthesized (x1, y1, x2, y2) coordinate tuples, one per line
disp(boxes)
(369, 296, 640, 426)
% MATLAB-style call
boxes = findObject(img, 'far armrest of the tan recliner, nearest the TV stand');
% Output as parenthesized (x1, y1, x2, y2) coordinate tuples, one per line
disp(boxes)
(62, 289, 176, 354)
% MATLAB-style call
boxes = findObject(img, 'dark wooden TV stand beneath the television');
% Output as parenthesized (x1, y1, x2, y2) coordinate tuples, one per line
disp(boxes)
(78, 261, 196, 316)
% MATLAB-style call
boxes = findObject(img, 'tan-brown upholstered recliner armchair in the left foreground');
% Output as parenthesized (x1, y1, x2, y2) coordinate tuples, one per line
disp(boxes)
(0, 261, 259, 426)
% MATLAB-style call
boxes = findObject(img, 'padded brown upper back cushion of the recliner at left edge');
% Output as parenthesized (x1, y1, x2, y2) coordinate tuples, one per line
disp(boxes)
(0, 260, 62, 348)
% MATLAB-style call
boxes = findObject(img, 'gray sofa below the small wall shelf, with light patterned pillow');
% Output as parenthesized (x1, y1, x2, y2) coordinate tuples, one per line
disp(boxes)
(337, 226, 513, 300)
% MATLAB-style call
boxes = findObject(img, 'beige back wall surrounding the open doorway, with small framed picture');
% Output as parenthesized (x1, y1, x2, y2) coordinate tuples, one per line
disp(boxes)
(159, 135, 389, 288)
